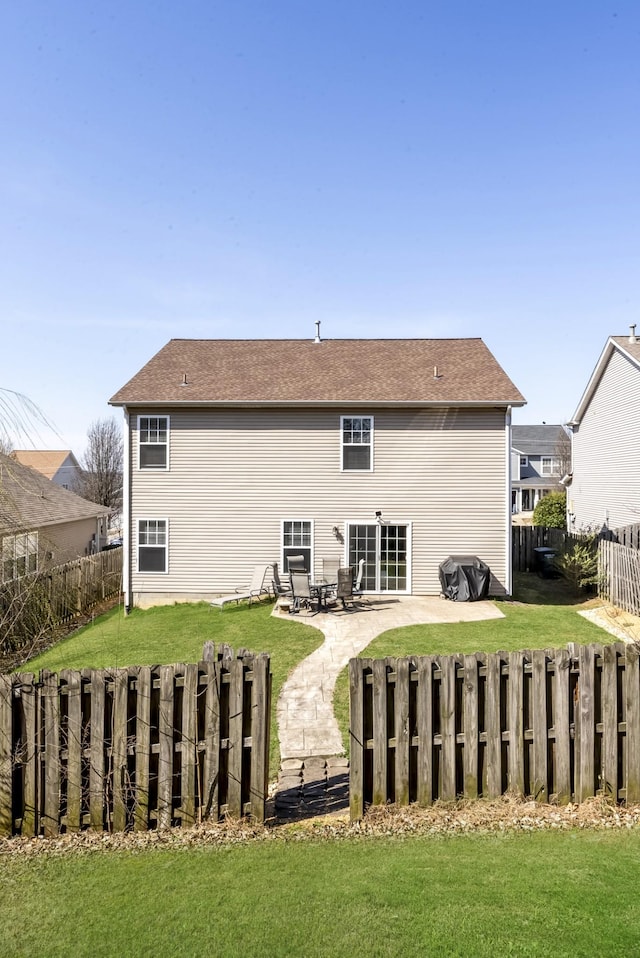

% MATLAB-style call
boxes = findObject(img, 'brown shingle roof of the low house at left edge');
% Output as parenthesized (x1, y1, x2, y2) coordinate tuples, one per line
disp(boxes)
(0, 454, 109, 532)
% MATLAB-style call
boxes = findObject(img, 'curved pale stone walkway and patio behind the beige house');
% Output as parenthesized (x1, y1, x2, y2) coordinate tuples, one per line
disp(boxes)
(273, 596, 503, 761)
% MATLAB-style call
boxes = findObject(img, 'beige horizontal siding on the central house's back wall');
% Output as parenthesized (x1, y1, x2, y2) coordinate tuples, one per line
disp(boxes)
(130, 407, 509, 596)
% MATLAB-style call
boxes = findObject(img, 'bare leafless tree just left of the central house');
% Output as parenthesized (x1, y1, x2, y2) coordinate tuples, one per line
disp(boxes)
(80, 416, 124, 518)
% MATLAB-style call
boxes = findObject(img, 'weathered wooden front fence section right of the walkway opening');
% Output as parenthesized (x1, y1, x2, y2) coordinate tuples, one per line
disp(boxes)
(349, 644, 640, 819)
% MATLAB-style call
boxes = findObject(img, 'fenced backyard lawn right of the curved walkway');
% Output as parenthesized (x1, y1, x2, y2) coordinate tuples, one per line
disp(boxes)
(333, 573, 613, 754)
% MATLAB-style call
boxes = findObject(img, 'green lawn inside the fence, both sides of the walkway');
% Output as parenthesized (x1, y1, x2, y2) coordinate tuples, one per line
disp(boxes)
(22, 575, 610, 775)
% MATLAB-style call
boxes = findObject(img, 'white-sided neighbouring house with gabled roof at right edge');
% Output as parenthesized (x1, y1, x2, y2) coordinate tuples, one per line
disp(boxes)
(567, 325, 640, 531)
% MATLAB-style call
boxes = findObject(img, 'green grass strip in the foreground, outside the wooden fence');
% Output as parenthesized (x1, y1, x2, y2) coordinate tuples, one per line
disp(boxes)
(0, 831, 640, 958)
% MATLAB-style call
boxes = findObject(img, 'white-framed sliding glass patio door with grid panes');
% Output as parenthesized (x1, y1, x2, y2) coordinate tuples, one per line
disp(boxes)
(347, 522, 410, 592)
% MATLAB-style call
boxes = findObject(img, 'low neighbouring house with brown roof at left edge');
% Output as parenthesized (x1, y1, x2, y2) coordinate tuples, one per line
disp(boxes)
(0, 455, 107, 581)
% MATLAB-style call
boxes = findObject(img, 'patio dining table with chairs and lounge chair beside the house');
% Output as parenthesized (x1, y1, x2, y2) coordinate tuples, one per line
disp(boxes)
(211, 555, 365, 615)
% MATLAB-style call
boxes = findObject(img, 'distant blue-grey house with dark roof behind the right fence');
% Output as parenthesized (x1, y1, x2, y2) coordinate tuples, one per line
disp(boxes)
(511, 423, 571, 525)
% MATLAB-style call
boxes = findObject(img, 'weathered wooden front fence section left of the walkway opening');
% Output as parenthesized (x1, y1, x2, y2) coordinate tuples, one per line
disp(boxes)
(0, 643, 271, 837)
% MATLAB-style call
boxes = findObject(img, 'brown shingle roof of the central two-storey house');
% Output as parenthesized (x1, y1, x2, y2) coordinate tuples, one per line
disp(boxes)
(109, 339, 525, 406)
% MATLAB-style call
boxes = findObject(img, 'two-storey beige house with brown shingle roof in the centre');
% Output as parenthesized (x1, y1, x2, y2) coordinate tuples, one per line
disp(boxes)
(110, 335, 524, 607)
